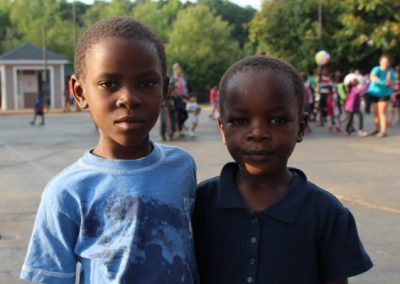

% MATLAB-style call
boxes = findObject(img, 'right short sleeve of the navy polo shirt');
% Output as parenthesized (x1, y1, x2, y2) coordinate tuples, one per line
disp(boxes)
(318, 207, 372, 282)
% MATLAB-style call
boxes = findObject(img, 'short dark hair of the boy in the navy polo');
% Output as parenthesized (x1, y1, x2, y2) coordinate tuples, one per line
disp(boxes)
(218, 56, 304, 116)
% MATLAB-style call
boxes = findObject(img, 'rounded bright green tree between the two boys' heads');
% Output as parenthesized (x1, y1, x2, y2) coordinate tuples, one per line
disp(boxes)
(166, 4, 241, 97)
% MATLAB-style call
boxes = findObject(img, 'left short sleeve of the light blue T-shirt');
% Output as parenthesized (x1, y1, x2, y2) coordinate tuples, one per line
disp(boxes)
(20, 188, 79, 283)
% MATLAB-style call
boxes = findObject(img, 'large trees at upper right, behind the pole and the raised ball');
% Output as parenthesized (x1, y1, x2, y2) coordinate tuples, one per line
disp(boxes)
(250, 0, 400, 71)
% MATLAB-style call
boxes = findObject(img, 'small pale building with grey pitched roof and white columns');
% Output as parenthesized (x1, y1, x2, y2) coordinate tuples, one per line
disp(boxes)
(0, 43, 68, 110)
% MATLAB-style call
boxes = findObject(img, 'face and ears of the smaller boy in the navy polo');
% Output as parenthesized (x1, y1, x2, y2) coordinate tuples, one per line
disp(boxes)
(218, 71, 306, 175)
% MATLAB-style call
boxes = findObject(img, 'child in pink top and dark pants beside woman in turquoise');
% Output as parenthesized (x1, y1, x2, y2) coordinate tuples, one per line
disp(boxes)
(344, 73, 368, 137)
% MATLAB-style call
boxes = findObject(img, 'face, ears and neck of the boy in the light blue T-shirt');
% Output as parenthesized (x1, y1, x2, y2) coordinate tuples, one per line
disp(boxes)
(73, 37, 168, 159)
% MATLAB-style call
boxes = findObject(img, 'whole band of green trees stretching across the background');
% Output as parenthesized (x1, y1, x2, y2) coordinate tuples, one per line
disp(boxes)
(0, 0, 400, 80)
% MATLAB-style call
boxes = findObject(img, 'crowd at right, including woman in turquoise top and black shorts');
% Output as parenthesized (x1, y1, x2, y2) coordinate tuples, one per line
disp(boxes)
(303, 55, 400, 138)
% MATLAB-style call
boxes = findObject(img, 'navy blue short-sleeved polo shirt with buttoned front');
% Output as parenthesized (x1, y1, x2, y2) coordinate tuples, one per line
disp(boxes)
(193, 163, 372, 284)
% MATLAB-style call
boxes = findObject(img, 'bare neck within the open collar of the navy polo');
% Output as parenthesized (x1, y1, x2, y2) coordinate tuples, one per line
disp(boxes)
(236, 169, 293, 212)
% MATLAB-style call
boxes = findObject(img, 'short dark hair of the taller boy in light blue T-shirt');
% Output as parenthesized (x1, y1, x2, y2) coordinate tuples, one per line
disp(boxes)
(74, 16, 167, 77)
